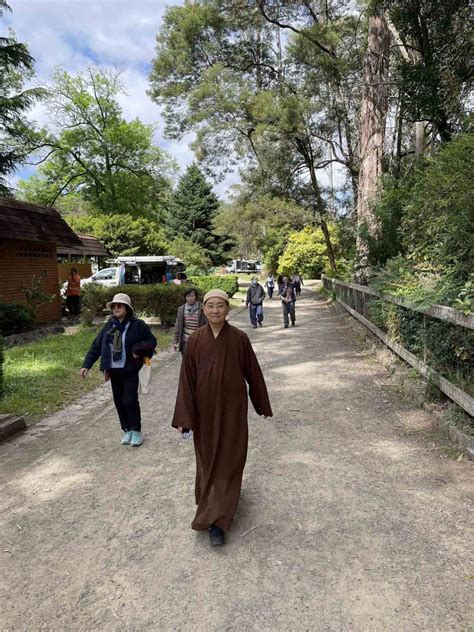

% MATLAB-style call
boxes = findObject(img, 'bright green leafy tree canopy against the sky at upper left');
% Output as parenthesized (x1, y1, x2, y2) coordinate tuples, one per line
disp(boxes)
(19, 67, 174, 217)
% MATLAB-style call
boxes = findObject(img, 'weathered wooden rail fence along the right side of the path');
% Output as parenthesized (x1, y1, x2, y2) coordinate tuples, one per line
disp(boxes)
(322, 275, 474, 416)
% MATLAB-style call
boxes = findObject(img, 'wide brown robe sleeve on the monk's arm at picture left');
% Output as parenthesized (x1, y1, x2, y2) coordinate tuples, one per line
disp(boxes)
(171, 336, 197, 429)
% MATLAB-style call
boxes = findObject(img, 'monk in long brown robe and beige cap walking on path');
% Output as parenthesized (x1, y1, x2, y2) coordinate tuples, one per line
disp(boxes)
(172, 290, 272, 545)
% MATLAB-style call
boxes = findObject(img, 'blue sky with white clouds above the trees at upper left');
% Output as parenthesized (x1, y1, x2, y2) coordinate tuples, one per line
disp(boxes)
(2, 0, 238, 197)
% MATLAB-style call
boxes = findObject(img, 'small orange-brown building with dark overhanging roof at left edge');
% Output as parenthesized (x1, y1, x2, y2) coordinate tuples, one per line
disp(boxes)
(0, 198, 83, 322)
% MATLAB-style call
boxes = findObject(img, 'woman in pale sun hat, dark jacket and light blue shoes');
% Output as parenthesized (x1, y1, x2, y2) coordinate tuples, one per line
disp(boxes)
(80, 293, 156, 446)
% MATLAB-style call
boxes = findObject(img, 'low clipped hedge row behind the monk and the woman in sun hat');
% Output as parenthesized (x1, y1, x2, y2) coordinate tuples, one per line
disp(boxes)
(81, 276, 238, 326)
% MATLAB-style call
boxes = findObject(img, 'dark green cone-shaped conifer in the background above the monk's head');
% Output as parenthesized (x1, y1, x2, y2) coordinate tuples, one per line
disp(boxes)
(167, 163, 222, 265)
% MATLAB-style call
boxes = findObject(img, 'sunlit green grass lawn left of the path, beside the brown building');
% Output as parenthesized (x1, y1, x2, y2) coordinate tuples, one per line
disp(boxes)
(0, 327, 171, 416)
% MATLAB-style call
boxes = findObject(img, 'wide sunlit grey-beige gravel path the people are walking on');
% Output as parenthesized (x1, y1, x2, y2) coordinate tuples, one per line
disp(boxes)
(0, 289, 474, 632)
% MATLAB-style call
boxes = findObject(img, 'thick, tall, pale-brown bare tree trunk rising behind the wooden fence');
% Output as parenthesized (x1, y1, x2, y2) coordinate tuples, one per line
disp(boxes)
(356, 15, 390, 283)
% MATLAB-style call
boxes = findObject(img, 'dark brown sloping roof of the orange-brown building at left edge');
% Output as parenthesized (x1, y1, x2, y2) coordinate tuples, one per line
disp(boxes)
(0, 198, 83, 247)
